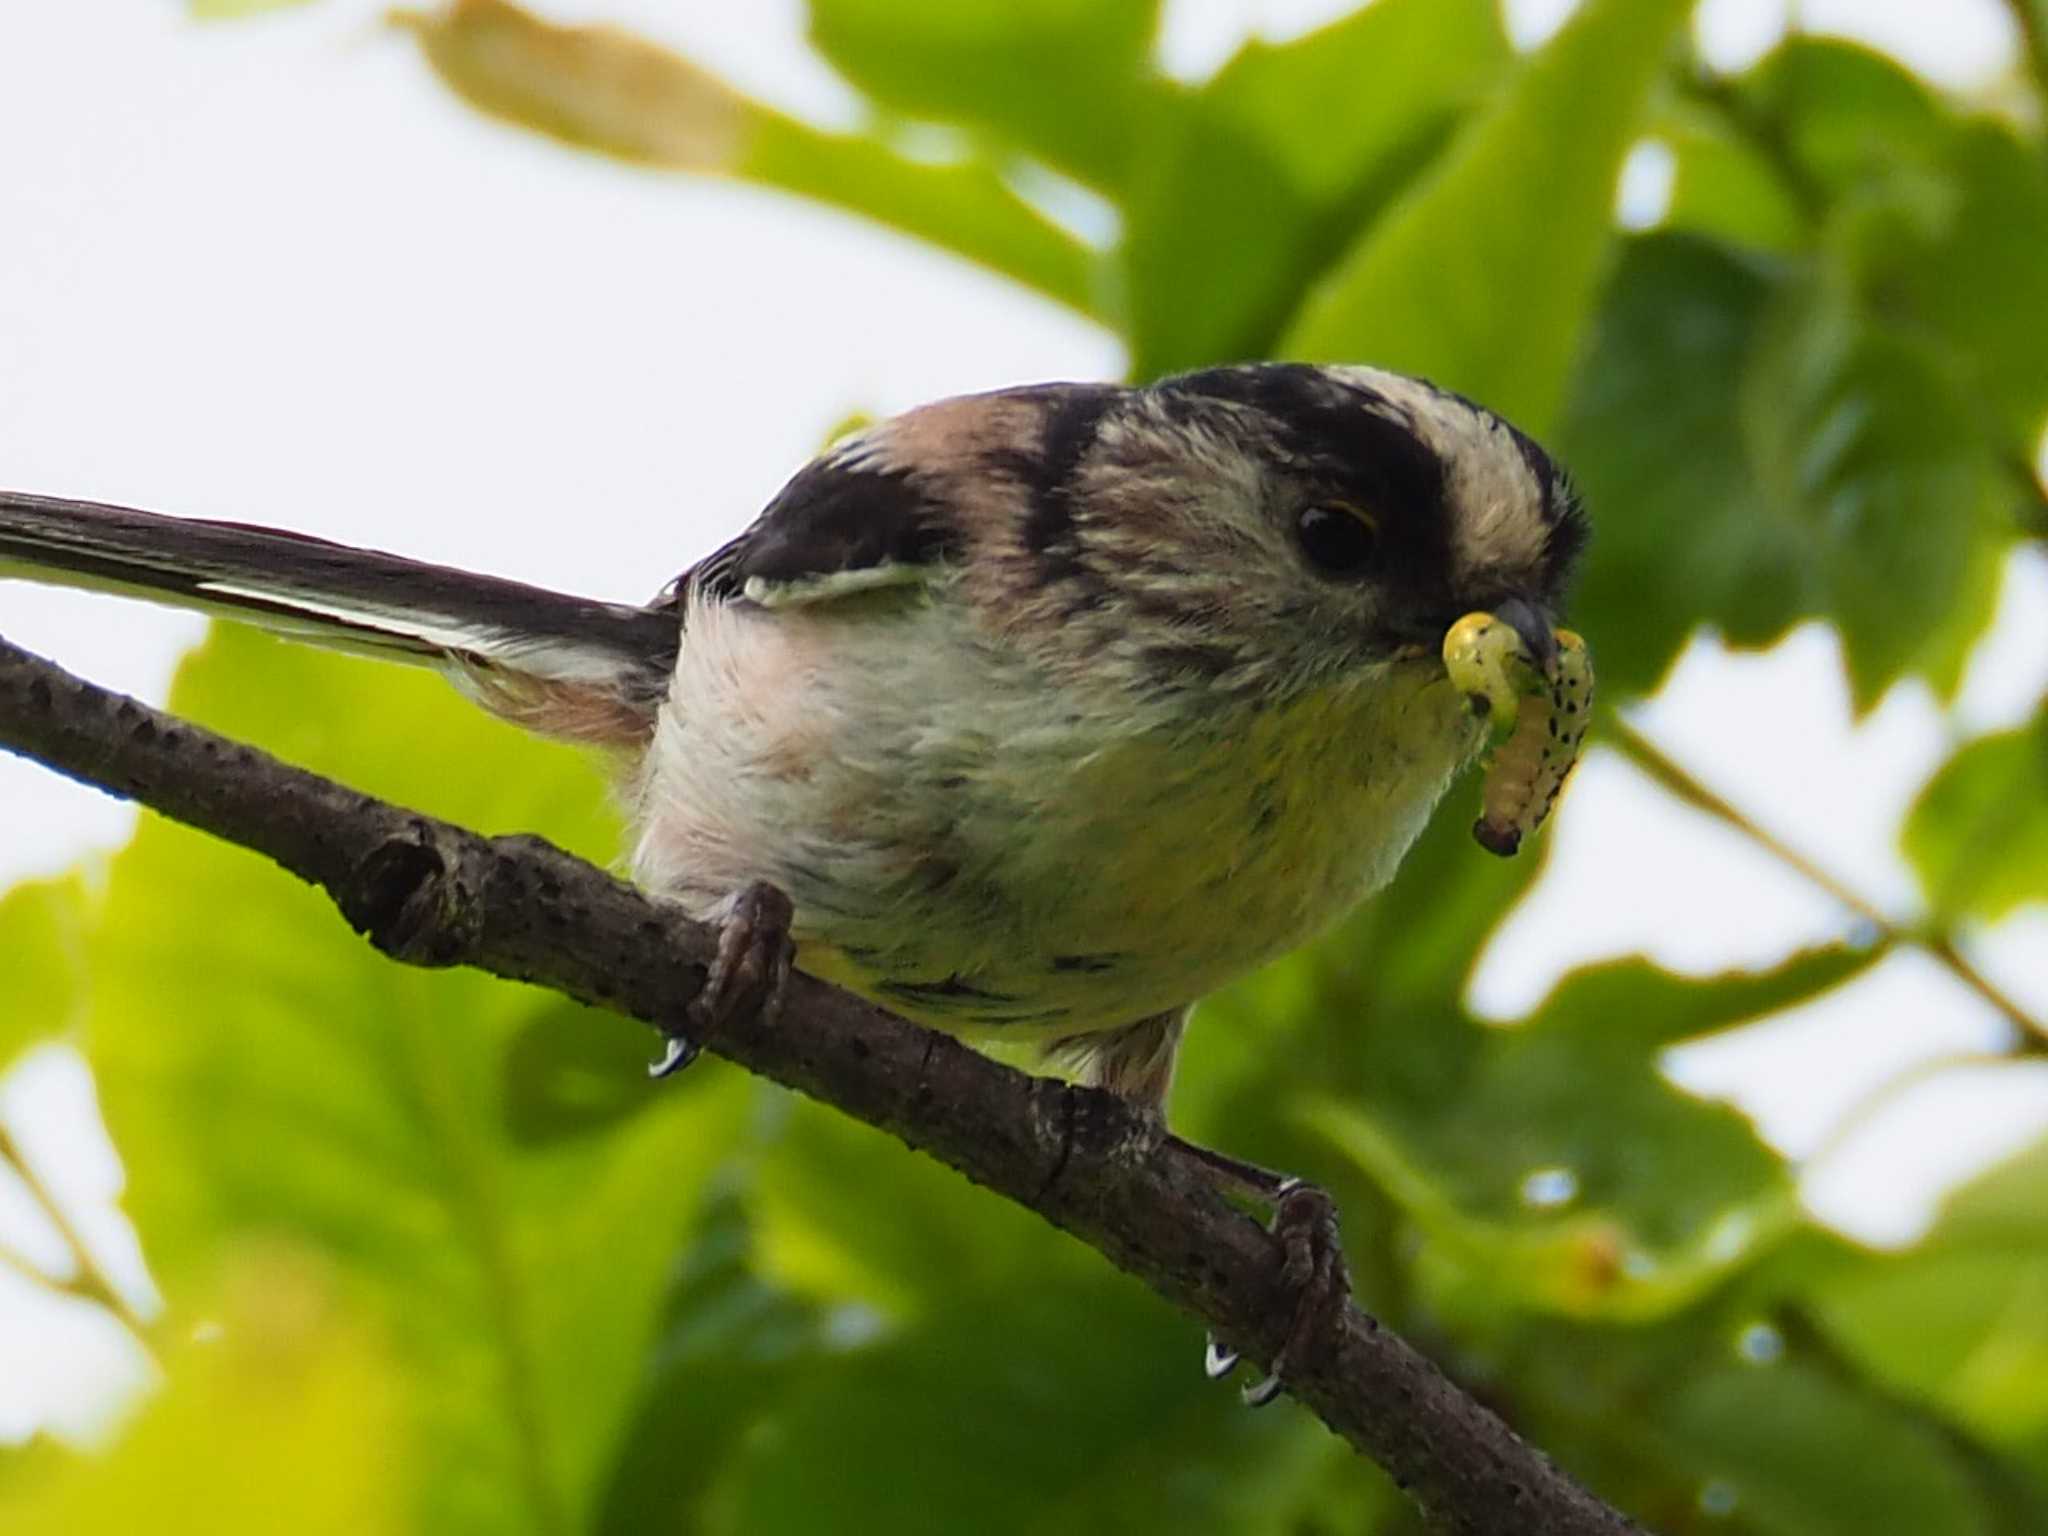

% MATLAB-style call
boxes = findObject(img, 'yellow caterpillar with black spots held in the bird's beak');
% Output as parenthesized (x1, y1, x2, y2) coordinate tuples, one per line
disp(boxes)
(1444, 612, 1593, 858)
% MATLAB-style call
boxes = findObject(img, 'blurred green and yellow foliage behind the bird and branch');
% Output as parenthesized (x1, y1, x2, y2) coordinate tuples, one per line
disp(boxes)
(0, 0, 2048, 1536)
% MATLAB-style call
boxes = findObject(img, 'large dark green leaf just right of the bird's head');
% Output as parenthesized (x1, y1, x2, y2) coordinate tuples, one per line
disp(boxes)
(1559, 233, 2013, 709)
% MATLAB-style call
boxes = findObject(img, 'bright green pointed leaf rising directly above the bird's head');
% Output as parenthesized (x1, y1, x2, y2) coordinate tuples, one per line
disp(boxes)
(1284, 0, 1692, 434)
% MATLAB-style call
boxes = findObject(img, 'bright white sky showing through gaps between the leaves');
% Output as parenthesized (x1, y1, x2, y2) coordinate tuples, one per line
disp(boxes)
(0, 0, 2048, 1440)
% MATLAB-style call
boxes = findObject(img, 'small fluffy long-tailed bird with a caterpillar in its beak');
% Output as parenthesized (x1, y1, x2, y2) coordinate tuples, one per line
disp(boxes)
(0, 362, 1587, 1400)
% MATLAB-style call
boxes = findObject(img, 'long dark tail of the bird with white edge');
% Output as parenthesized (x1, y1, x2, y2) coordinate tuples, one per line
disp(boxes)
(0, 492, 680, 745)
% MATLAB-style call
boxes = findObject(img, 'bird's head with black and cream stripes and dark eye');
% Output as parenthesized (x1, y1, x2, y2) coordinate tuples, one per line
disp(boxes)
(999, 365, 1585, 694)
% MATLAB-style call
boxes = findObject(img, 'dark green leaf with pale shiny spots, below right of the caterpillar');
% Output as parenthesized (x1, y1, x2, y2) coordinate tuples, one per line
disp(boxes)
(1309, 950, 1868, 1317)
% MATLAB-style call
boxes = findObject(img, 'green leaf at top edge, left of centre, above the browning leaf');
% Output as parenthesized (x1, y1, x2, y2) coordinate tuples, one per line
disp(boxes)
(809, 0, 1159, 193)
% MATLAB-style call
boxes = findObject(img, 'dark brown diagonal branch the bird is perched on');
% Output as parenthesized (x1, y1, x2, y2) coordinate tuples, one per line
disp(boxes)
(0, 641, 1636, 1536)
